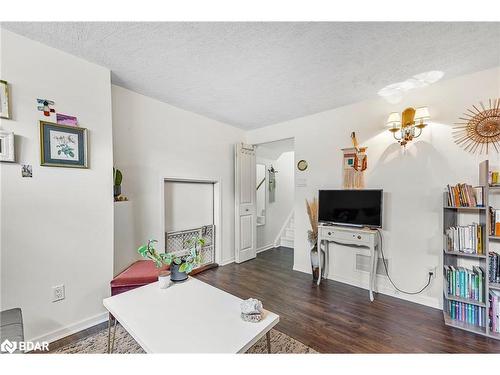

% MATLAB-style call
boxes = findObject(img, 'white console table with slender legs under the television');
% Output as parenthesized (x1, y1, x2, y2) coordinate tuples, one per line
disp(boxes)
(318, 223, 379, 301)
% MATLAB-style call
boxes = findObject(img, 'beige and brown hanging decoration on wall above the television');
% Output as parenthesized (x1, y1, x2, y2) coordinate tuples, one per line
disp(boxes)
(342, 132, 368, 189)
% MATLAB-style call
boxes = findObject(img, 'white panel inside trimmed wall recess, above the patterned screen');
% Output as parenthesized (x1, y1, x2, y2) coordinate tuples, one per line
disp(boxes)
(164, 181, 214, 232)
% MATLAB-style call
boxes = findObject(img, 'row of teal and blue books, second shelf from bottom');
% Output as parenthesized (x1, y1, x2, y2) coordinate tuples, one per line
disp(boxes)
(444, 266, 485, 302)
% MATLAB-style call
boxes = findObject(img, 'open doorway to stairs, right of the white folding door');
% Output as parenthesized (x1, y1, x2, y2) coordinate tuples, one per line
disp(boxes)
(255, 138, 295, 253)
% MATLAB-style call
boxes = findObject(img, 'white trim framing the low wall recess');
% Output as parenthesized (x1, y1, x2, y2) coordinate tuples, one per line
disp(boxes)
(158, 176, 222, 265)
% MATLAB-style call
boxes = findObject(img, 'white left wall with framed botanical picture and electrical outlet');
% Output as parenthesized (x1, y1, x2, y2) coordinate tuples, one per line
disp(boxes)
(0, 29, 113, 340)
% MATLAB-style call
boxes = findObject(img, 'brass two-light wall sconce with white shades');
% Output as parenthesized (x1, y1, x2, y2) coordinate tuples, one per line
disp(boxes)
(387, 107, 430, 147)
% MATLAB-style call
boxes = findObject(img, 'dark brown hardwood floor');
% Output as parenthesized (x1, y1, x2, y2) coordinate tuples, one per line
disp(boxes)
(195, 248, 500, 353)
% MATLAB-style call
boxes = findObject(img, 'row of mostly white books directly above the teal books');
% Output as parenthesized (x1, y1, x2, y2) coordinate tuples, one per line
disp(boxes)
(445, 223, 483, 254)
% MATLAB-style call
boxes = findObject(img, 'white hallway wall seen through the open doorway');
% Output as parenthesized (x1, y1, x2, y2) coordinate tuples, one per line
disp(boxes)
(257, 147, 295, 249)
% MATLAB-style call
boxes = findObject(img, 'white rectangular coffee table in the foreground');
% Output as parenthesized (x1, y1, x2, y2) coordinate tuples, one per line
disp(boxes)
(103, 277, 279, 353)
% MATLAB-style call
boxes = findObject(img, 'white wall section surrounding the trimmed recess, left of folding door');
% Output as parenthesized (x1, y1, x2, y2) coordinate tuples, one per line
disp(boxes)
(112, 86, 244, 263)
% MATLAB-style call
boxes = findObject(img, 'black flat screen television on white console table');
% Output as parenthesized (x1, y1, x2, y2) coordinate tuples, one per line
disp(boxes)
(318, 190, 383, 228)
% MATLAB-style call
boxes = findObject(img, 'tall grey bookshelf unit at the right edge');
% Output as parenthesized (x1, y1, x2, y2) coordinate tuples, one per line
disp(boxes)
(443, 160, 500, 340)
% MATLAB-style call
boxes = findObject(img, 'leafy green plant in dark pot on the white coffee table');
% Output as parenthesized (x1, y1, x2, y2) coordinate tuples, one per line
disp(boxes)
(137, 237, 205, 282)
